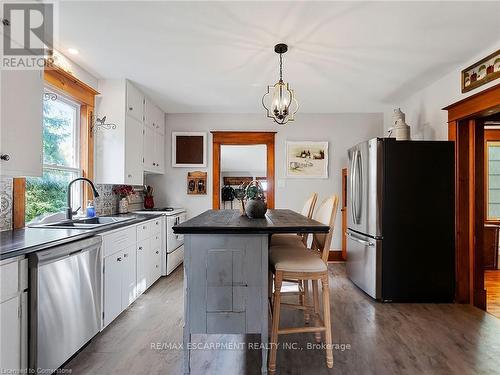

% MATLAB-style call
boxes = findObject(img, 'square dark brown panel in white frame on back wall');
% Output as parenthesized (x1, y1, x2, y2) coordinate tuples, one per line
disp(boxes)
(172, 132, 207, 168)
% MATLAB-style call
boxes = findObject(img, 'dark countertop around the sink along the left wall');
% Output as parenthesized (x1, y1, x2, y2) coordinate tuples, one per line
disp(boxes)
(0, 213, 162, 260)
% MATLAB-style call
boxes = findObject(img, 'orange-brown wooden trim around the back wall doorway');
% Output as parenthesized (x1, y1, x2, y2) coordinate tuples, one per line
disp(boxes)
(211, 131, 276, 210)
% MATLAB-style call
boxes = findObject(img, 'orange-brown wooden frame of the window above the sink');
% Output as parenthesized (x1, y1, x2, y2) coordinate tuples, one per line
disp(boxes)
(12, 66, 99, 229)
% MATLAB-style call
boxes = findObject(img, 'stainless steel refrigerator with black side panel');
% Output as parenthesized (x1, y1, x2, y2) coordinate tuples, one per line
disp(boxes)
(346, 138, 455, 302)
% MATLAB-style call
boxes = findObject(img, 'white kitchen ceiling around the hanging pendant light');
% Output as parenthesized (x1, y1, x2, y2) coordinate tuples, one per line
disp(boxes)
(59, 1, 500, 113)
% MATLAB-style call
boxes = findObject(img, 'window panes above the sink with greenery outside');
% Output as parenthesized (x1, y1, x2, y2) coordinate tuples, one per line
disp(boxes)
(25, 89, 82, 223)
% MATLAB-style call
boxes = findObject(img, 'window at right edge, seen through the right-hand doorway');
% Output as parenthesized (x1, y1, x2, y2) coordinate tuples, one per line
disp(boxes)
(486, 141, 500, 220)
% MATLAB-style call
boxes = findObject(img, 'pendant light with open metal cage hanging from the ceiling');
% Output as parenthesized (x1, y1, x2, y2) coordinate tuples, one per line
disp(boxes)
(262, 43, 299, 125)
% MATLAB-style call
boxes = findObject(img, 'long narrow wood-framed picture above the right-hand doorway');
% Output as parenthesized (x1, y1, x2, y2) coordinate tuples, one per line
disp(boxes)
(460, 49, 500, 93)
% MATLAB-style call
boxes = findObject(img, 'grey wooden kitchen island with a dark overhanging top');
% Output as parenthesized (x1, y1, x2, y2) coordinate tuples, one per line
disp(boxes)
(173, 210, 329, 374)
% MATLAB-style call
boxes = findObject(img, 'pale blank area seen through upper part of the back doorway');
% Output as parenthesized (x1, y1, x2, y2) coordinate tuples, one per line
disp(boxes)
(220, 145, 267, 174)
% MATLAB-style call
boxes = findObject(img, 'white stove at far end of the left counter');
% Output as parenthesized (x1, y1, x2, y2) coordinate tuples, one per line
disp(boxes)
(134, 207, 186, 276)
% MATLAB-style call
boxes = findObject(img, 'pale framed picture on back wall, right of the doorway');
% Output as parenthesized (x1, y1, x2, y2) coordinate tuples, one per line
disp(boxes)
(286, 141, 328, 178)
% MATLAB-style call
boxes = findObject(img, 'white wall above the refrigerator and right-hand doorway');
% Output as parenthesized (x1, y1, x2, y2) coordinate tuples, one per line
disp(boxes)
(384, 42, 500, 140)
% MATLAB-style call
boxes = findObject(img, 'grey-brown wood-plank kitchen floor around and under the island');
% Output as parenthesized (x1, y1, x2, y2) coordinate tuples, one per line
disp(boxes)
(66, 264, 500, 375)
